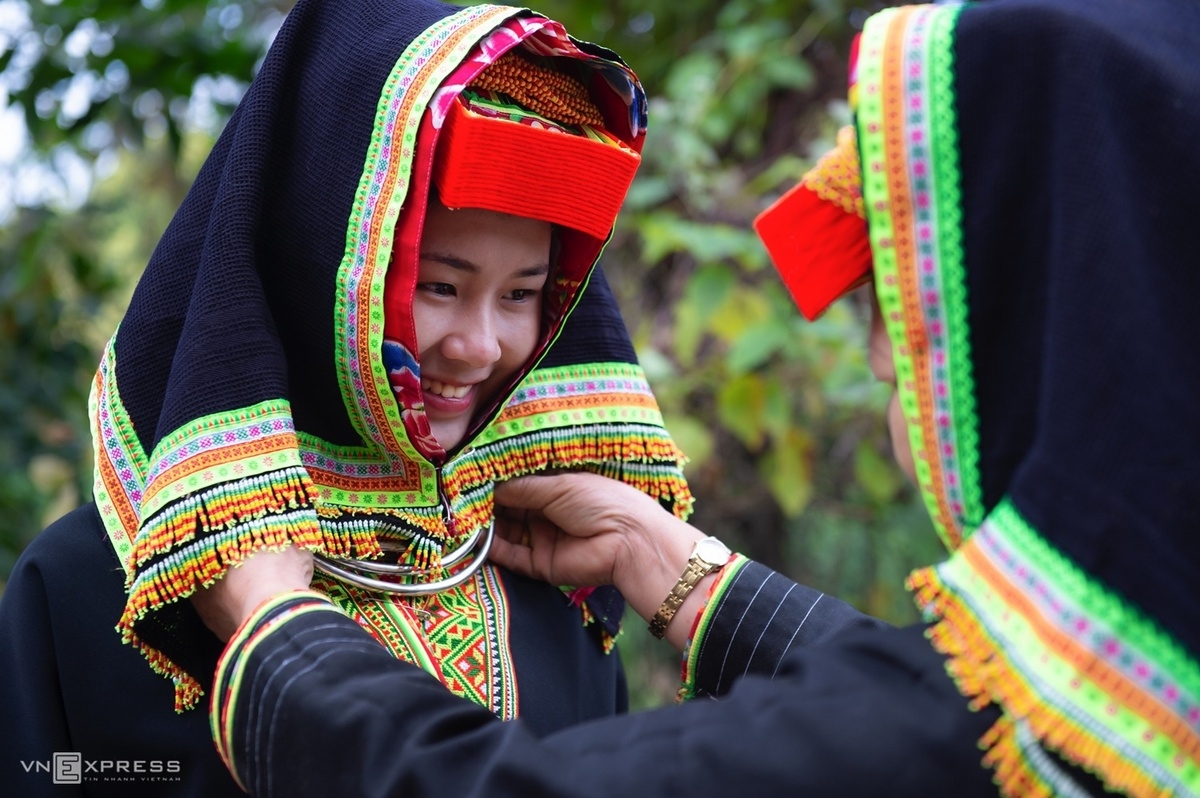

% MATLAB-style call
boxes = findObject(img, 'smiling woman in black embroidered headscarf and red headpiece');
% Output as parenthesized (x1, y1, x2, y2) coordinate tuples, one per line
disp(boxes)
(0, 0, 691, 796)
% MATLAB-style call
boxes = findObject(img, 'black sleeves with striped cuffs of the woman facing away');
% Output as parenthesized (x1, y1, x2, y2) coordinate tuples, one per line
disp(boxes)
(212, 576, 998, 798)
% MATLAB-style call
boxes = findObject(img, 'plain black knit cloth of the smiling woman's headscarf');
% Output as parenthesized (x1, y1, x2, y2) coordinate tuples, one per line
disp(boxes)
(116, 0, 456, 452)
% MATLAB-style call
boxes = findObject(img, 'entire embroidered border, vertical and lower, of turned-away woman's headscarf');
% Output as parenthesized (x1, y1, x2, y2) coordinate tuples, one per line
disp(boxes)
(856, 5, 1200, 796)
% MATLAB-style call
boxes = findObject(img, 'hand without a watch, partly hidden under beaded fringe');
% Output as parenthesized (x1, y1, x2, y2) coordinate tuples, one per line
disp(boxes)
(191, 546, 312, 642)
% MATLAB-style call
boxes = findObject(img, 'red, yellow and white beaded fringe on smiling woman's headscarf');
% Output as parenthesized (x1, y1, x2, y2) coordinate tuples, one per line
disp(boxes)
(118, 425, 692, 712)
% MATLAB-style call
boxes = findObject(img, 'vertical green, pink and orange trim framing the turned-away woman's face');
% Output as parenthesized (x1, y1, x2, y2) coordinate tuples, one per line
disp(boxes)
(856, 6, 983, 550)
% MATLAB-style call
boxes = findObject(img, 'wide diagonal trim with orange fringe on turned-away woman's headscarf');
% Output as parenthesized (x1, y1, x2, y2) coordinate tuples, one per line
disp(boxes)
(910, 500, 1200, 796)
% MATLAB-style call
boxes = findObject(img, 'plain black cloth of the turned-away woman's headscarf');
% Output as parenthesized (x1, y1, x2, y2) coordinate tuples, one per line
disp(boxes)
(955, 0, 1200, 656)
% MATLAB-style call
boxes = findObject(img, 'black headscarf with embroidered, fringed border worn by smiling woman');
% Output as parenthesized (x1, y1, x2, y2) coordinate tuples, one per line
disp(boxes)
(90, 0, 691, 715)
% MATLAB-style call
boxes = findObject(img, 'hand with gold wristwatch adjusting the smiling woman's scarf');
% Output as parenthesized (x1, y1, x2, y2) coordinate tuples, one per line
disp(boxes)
(491, 473, 712, 648)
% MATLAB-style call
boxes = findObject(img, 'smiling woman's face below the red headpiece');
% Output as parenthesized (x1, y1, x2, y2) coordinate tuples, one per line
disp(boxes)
(413, 200, 551, 450)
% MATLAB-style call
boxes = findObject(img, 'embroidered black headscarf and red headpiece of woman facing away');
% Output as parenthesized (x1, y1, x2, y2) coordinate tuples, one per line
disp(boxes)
(758, 0, 1200, 796)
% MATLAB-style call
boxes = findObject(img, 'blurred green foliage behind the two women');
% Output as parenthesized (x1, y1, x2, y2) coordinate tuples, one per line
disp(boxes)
(0, 0, 938, 706)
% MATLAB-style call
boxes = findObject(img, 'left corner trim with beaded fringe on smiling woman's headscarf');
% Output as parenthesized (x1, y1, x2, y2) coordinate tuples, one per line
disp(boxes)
(89, 345, 345, 712)
